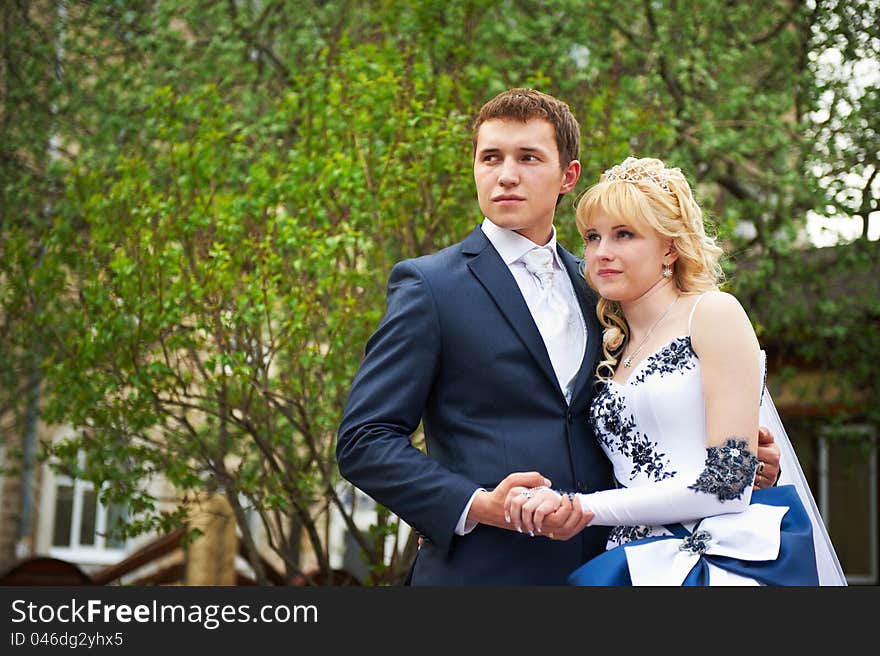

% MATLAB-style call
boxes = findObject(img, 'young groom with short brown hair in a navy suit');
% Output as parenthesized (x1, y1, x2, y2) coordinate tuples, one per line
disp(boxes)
(336, 89, 776, 585)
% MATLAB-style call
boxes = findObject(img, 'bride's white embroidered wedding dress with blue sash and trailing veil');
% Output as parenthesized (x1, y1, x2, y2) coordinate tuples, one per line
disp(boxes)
(570, 316, 846, 585)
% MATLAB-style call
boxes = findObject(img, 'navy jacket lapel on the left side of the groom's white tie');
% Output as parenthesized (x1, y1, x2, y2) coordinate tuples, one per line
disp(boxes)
(462, 227, 562, 396)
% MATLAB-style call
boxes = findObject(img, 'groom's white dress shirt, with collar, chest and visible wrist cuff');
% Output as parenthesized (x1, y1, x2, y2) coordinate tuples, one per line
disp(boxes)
(455, 218, 587, 535)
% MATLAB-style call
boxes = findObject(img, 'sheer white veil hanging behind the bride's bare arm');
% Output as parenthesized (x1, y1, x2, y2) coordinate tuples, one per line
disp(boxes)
(760, 352, 846, 585)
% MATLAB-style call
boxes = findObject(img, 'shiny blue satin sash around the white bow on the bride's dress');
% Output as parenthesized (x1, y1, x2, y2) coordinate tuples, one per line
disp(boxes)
(568, 485, 819, 586)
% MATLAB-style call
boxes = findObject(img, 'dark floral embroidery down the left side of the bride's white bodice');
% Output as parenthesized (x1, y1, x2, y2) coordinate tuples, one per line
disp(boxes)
(590, 386, 677, 481)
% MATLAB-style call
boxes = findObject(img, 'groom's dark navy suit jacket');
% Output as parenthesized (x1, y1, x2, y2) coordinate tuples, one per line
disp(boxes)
(336, 227, 611, 585)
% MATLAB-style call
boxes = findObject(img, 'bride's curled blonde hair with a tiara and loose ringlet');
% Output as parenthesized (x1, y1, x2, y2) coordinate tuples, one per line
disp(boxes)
(577, 157, 723, 380)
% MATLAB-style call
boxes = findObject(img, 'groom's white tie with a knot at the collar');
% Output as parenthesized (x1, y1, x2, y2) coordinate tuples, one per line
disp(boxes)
(522, 248, 580, 395)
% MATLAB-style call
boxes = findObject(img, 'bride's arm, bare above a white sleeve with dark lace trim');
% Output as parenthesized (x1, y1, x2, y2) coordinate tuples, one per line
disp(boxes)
(509, 292, 762, 530)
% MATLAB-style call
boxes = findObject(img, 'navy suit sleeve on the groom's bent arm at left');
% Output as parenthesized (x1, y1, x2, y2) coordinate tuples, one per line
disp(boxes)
(336, 260, 478, 549)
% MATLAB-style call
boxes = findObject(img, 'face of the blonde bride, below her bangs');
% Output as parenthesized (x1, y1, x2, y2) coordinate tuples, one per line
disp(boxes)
(584, 211, 674, 303)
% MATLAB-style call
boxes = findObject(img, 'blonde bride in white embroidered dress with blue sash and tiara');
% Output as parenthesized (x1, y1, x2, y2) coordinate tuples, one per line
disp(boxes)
(505, 157, 846, 585)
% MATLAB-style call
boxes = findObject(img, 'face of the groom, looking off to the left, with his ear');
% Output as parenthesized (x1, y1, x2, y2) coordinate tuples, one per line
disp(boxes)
(474, 118, 580, 245)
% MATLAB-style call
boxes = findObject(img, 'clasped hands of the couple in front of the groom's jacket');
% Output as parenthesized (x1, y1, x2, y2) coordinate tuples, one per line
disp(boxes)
(504, 486, 593, 540)
